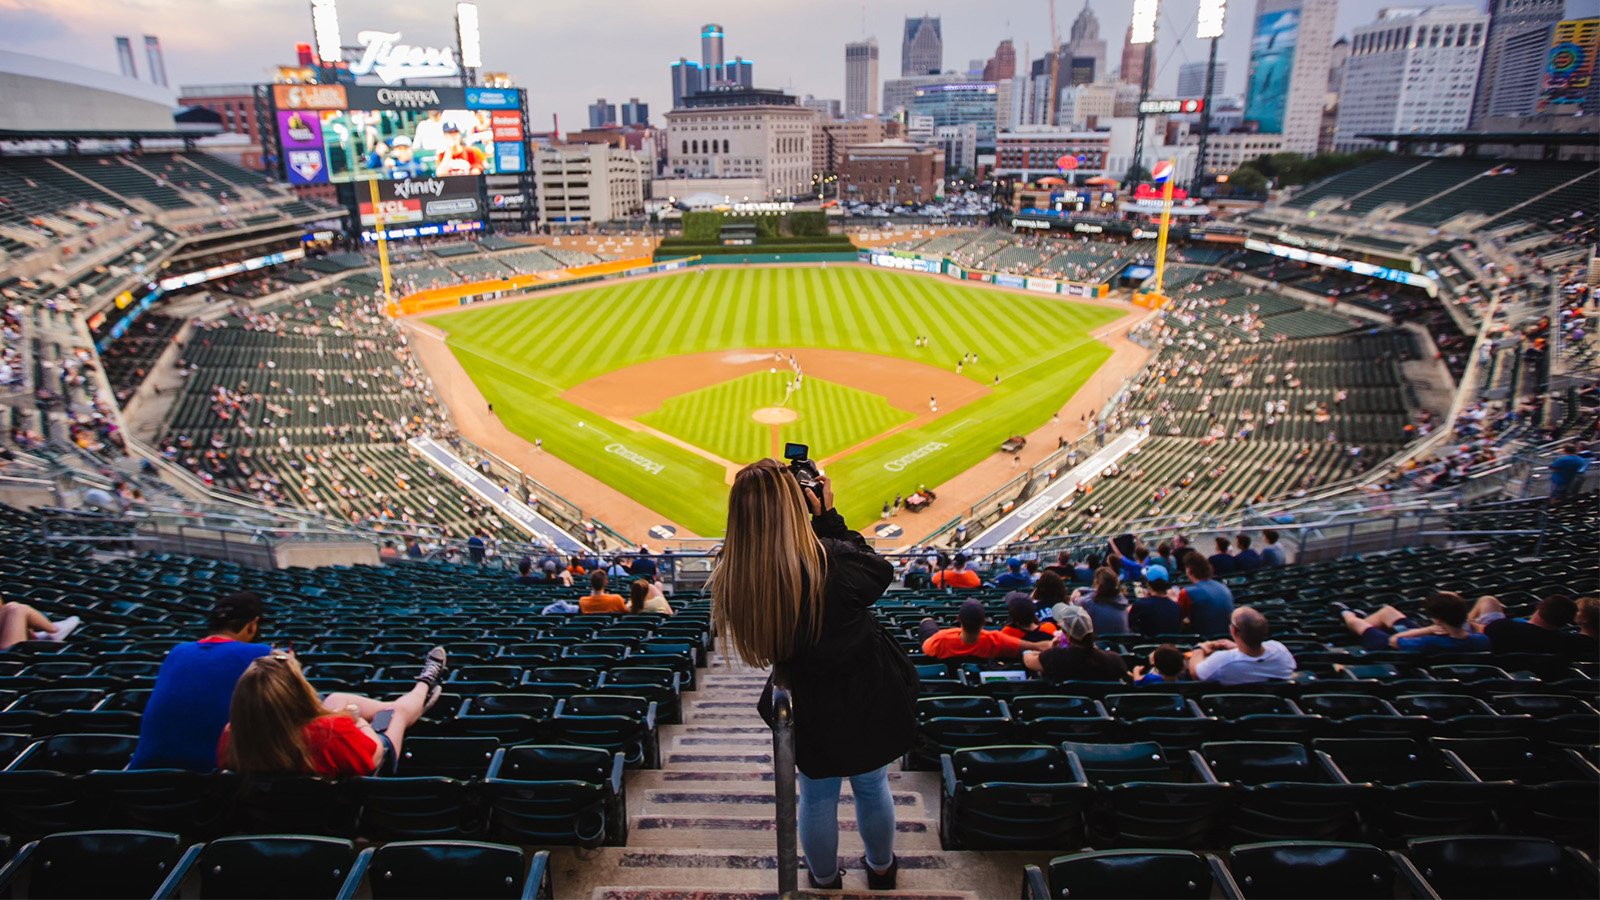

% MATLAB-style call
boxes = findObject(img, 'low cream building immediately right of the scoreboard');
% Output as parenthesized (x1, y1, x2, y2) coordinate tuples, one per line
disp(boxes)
(533, 143, 651, 224)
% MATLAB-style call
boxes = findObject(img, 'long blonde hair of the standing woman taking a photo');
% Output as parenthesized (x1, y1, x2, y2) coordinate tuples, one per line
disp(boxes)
(710, 460, 827, 668)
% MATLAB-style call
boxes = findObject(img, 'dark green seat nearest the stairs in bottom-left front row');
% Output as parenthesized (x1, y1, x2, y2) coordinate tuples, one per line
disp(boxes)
(355, 841, 554, 900)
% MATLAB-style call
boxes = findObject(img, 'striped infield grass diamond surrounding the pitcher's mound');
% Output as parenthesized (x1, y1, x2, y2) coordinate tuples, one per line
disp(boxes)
(638, 367, 912, 463)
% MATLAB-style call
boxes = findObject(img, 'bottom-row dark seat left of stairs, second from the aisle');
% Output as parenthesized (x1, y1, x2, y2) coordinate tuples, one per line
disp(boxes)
(155, 834, 373, 900)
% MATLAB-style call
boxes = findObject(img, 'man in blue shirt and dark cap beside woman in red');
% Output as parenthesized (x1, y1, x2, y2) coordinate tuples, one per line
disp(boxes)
(128, 591, 272, 772)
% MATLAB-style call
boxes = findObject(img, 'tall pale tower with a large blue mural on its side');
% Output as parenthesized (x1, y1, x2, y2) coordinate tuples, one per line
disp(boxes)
(1245, 0, 1339, 155)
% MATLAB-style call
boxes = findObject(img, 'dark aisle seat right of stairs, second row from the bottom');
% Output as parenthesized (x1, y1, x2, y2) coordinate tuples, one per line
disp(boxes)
(939, 746, 1090, 850)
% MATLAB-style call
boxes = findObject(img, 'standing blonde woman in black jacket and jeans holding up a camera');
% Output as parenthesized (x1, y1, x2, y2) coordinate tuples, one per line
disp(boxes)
(710, 460, 917, 890)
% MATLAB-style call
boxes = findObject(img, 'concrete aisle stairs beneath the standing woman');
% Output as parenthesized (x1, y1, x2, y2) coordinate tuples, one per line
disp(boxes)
(550, 653, 1048, 900)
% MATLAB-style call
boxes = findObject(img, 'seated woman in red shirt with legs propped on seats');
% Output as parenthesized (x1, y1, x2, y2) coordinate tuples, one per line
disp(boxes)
(216, 647, 446, 778)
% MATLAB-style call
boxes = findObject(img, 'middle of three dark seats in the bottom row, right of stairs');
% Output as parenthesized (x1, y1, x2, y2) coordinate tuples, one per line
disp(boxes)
(1227, 841, 1432, 900)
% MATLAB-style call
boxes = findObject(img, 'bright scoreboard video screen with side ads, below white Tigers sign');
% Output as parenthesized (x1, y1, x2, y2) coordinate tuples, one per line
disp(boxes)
(274, 85, 528, 184)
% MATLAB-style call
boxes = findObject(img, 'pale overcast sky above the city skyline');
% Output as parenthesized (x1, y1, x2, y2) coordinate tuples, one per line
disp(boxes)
(0, 0, 1600, 131)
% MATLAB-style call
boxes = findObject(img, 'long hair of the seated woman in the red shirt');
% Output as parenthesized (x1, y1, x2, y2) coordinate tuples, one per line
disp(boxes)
(221, 653, 333, 775)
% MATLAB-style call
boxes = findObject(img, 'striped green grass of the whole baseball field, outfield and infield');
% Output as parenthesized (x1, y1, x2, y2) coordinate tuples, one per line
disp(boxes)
(429, 266, 1118, 538)
